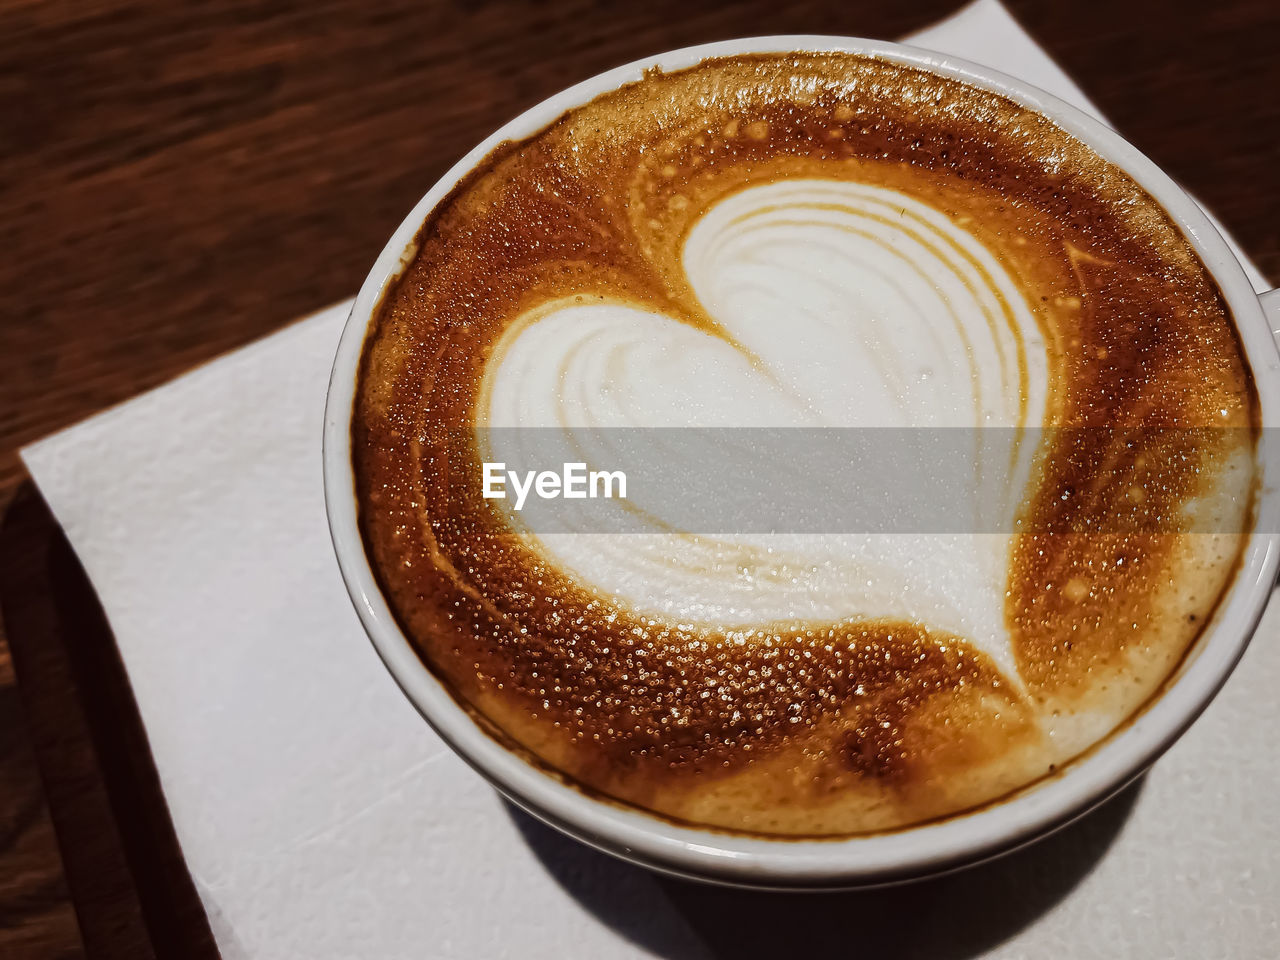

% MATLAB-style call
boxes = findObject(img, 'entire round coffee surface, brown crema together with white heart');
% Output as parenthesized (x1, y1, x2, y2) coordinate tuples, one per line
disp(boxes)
(352, 54, 1258, 836)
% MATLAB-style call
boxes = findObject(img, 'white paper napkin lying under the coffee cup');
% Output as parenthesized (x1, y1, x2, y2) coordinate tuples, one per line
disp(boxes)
(23, 0, 1280, 960)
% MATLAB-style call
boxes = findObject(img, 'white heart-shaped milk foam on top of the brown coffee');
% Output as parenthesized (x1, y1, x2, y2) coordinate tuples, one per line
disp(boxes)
(477, 179, 1048, 678)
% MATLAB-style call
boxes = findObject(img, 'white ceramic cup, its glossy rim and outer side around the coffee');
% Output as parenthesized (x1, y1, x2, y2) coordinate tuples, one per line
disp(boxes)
(324, 36, 1280, 888)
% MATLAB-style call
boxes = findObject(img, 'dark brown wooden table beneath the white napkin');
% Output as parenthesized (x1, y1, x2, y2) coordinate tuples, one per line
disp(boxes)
(0, 0, 1280, 960)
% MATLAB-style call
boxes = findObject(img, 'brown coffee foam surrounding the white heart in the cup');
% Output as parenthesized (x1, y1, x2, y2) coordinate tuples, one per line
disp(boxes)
(352, 55, 1257, 835)
